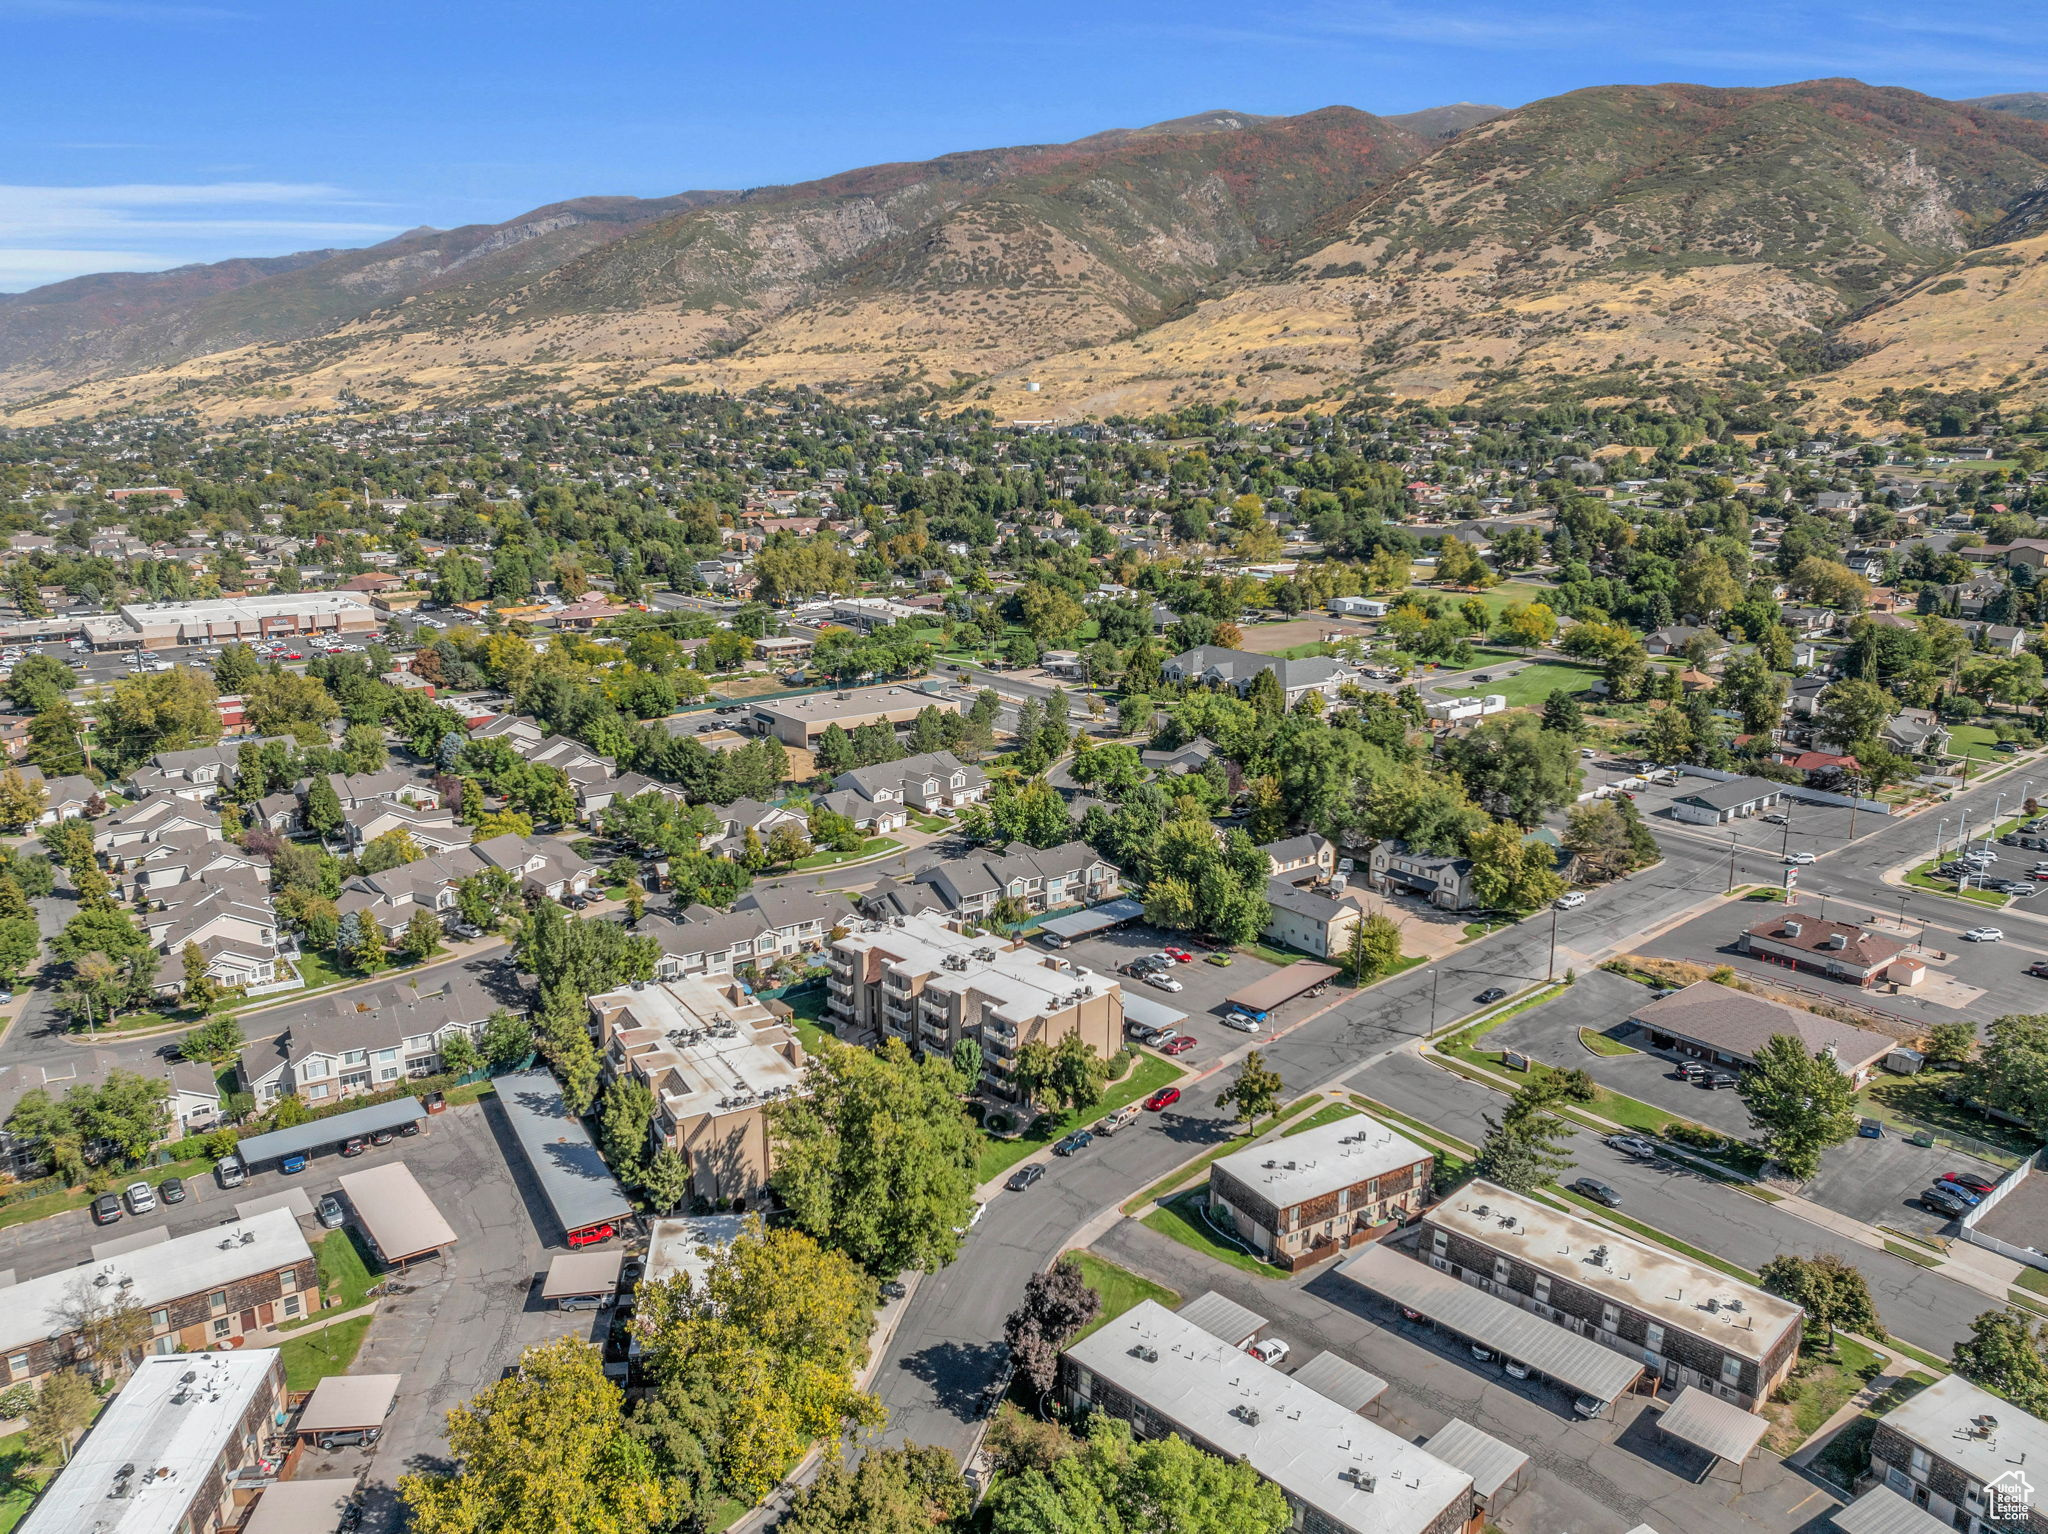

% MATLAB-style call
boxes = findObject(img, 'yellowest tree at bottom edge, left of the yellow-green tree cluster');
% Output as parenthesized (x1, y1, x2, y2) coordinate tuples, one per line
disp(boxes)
(399, 1337, 684, 1534)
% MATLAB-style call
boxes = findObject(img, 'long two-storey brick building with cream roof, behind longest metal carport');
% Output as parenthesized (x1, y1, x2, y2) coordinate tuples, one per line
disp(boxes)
(1421, 1180, 1804, 1409)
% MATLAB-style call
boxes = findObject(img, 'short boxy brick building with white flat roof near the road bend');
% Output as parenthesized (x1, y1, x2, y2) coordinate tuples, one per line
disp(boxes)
(1208, 1114, 1436, 1268)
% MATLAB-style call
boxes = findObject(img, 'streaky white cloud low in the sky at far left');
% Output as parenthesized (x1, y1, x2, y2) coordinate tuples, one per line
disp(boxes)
(0, 181, 406, 291)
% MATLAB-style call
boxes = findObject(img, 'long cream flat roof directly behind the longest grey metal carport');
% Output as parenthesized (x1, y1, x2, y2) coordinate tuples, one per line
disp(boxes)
(1423, 1180, 1804, 1362)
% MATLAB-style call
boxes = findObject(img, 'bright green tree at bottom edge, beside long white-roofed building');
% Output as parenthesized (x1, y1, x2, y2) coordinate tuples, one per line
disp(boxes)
(983, 1413, 1294, 1534)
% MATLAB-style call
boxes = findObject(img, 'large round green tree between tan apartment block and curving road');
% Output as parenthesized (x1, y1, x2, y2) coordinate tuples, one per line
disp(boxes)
(766, 1038, 975, 1274)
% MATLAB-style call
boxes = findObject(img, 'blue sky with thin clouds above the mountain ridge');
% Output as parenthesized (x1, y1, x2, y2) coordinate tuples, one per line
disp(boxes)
(0, 0, 2048, 291)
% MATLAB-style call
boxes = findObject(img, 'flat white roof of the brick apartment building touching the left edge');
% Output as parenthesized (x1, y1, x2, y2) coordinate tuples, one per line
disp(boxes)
(0, 1208, 313, 1348)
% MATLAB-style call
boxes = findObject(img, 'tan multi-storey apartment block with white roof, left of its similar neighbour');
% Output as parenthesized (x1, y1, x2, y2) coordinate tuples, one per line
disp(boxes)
(590, 975, 805, 1204)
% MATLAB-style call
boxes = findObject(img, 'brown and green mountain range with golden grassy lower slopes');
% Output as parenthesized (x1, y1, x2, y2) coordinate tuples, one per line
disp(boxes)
(12, 80, 2048, 424)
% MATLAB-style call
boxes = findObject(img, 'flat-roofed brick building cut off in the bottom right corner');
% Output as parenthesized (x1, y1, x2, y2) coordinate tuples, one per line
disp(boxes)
(1870, 1374, 2048, 1534)
